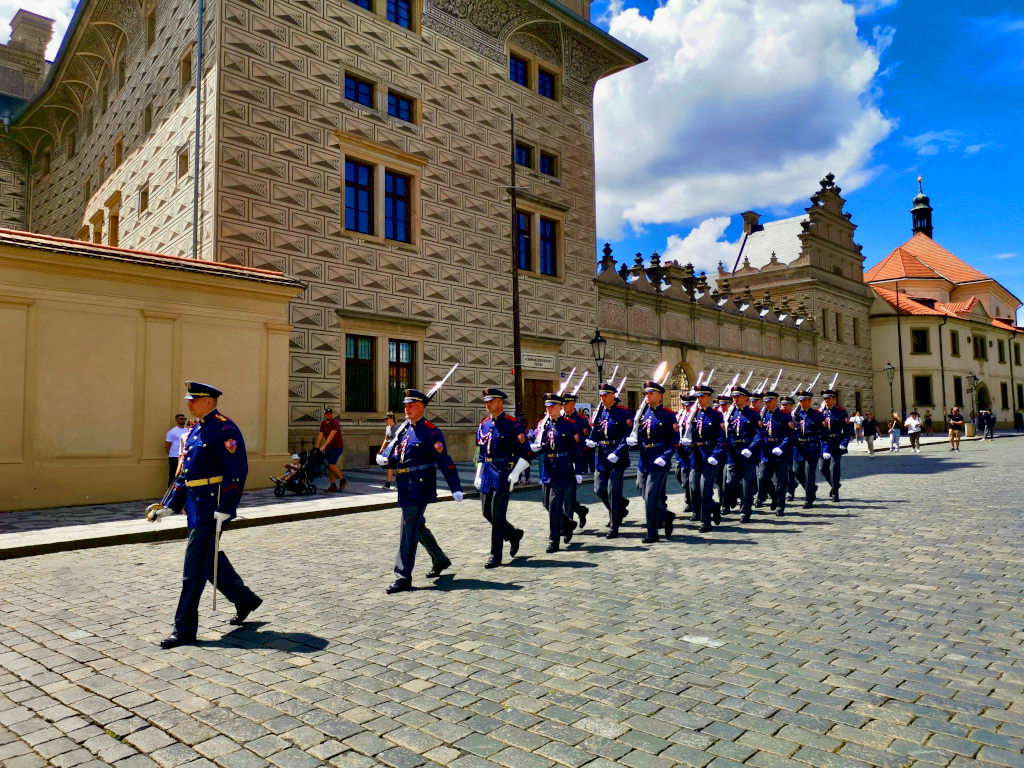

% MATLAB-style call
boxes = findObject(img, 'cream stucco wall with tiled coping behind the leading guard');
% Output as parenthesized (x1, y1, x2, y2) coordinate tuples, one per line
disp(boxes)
(0, 240, 298, 510)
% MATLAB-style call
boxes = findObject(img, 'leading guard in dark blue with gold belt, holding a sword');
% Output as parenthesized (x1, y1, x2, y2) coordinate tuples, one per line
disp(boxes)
(160, 381, 263, 648)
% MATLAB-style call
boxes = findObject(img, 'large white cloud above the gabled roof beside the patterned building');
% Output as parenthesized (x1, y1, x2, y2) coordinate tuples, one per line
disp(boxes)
(595, 0, 894, 240)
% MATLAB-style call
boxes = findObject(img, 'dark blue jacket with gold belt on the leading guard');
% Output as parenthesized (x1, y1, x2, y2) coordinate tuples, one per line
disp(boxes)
(167, 409, 249, 528)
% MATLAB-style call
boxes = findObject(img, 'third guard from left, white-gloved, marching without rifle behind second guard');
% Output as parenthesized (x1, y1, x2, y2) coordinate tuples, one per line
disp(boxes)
(474, 388, 531, 568)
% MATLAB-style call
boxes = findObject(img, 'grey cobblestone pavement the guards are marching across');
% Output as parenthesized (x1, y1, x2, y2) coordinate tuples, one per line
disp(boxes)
(0, 440, 1024, 768)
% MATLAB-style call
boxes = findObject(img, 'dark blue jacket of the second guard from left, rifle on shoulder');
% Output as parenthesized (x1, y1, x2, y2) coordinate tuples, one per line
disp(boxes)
(388, 419, 462, 507)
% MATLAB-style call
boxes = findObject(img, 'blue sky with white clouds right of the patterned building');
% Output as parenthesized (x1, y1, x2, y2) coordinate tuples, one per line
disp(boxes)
(591, 0, 1024, 323)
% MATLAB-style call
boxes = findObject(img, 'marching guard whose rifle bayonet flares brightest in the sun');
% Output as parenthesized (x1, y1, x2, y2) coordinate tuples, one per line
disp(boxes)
(637, 381, 679, 544)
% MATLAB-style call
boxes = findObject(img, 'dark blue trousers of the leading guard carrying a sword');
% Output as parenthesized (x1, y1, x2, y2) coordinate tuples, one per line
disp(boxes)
(174, 522, 259, 638)
